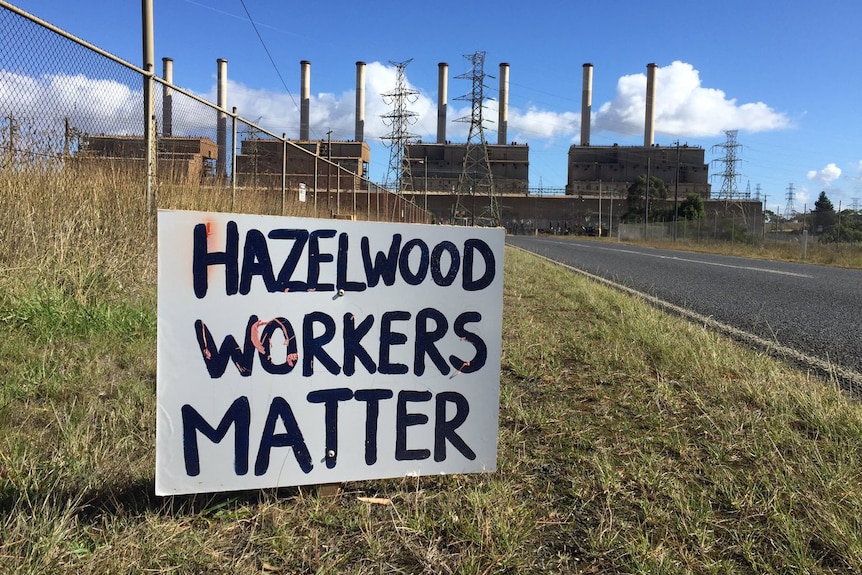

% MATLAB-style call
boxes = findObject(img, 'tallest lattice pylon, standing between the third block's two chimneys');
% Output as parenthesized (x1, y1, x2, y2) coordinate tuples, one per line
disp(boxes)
(452, 52, 500, 225)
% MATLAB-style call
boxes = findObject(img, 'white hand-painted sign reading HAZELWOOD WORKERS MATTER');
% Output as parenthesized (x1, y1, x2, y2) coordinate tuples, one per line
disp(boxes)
(156, 211, 504, 495)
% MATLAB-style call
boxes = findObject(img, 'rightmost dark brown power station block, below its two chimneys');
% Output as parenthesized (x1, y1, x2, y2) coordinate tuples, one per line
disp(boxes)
(566, 145, 711, 200)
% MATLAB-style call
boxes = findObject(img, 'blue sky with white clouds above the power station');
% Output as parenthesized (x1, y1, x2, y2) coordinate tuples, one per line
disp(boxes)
(6, 0, 862, 211)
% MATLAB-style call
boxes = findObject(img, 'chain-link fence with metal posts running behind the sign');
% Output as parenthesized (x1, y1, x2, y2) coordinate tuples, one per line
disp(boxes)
(0, 0, 429, 226)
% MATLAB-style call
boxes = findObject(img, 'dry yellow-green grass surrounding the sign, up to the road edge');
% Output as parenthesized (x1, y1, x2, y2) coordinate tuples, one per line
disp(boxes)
(5, 164, 862, 574)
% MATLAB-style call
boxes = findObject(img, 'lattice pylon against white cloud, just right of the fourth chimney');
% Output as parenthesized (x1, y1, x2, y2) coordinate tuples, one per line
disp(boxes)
(381, 58, 419, 194)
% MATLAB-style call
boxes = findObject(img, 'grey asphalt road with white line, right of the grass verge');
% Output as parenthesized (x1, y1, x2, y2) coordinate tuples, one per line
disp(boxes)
(506, 236, 862, 380)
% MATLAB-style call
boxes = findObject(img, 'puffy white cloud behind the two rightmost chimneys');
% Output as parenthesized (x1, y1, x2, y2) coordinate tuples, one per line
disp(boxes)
(594, 61, 790, 137)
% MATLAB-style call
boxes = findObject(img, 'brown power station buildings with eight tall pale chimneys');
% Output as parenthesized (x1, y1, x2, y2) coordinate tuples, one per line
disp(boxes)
(82, 60, 762, 237)
